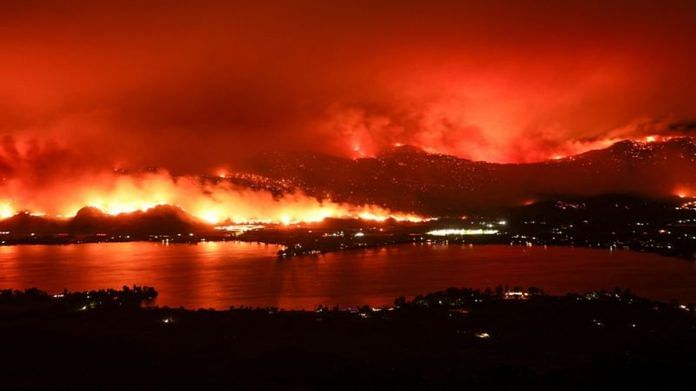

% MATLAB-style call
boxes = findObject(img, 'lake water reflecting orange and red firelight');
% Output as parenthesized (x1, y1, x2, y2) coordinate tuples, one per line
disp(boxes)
(0, 242, 696, 309)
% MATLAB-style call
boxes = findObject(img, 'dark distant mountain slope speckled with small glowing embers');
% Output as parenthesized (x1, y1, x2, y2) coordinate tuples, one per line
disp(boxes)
(243, 138, 696, 215)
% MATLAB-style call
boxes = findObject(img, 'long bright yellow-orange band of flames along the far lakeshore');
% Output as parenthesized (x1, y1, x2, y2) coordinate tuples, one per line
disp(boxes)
(0, 172, 423, 225)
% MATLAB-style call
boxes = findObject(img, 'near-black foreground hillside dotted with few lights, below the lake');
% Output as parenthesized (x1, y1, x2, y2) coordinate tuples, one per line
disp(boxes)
(0, 289, 696, 390)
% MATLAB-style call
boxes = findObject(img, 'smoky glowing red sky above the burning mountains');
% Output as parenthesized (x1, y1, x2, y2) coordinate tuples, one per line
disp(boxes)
(0, 0, 696, 172)
